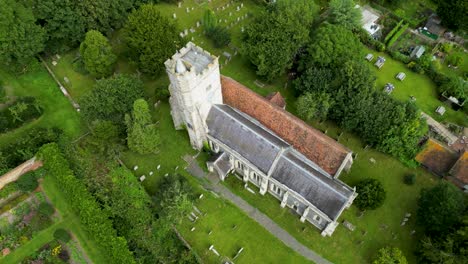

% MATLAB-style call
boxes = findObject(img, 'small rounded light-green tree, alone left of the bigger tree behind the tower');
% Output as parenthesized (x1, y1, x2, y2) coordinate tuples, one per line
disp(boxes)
(80, 30, 117, 78)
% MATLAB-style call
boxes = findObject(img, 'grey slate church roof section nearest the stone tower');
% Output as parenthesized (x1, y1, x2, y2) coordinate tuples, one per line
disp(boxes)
(206, 105, 289, 174)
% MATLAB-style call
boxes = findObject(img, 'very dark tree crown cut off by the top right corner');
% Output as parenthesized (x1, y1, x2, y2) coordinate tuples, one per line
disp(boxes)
(435, 0, 468, 31)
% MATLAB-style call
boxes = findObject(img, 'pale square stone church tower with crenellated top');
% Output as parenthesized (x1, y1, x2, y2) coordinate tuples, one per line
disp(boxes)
(164, 42, 223, 150)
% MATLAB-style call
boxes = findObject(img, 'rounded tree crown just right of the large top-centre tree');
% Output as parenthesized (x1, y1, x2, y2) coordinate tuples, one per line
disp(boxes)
(303, 23, 364, 68)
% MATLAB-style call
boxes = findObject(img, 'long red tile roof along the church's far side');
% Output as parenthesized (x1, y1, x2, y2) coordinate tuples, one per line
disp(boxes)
(221, 76, 351, 175)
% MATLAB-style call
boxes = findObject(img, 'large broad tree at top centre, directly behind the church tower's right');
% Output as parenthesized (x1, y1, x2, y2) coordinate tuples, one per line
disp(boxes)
(242, 0, 317, 81)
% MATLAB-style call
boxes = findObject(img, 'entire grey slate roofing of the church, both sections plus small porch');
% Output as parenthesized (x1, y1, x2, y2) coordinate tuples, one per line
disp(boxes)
(206, 105, 354, 220)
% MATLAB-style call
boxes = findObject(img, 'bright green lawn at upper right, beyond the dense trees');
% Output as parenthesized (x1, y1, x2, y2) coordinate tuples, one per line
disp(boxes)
(367, 49, 468, 126)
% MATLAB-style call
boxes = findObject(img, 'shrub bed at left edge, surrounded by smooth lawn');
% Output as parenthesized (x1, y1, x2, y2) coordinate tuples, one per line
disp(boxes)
(0, 97, 42, 133)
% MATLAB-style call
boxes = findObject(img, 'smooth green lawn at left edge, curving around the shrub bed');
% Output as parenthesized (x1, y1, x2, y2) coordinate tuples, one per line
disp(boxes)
(0, 63, 83, 145)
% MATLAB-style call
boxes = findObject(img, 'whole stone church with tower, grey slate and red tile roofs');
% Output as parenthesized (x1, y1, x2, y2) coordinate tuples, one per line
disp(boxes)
(165, 42, 357, 236)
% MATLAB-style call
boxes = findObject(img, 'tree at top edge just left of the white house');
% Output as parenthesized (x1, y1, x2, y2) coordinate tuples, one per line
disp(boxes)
(328, 0, 362, 30)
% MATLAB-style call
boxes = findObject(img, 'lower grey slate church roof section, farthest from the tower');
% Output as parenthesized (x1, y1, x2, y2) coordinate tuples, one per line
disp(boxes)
(271, 150, 353, 220)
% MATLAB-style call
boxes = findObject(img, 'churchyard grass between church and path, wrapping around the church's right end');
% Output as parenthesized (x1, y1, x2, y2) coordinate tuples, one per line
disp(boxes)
(221, 118, 437, 263)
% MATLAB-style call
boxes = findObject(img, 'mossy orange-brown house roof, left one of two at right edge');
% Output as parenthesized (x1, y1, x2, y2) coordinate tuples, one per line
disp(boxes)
(416, 139, 457, 176)
